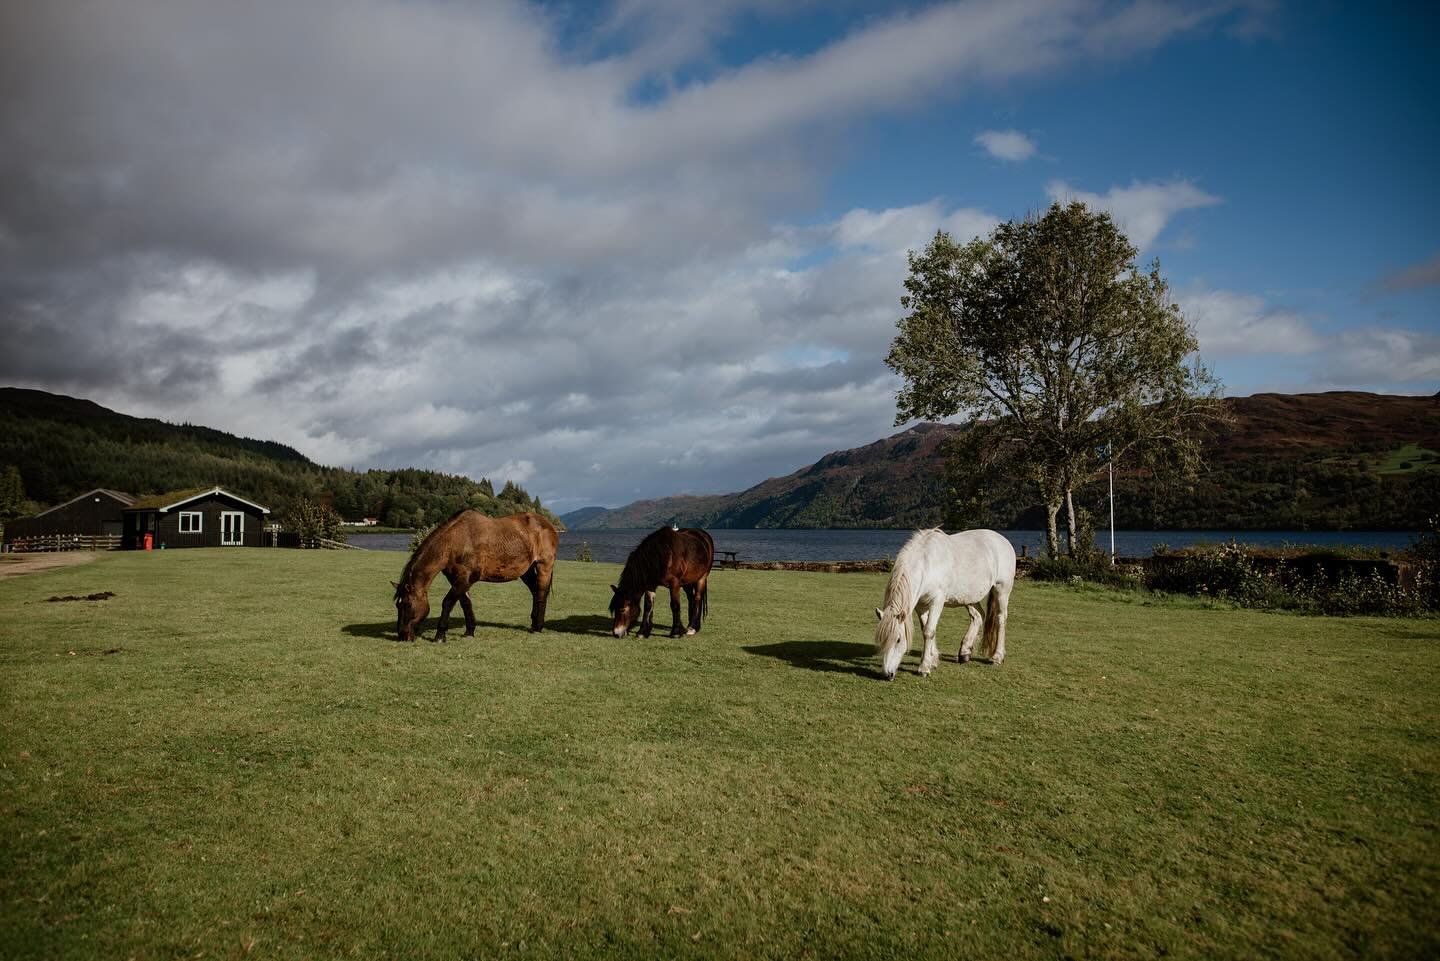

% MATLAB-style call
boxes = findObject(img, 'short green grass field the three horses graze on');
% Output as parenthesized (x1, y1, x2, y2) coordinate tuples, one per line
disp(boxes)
(0, 550, 1440, 958)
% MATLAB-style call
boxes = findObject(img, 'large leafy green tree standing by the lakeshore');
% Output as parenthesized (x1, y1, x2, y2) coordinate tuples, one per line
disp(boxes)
(886, 203, 1220, 556)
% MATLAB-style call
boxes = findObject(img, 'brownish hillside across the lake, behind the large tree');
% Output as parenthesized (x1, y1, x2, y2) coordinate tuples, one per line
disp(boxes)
(570, 392, 1440, 530)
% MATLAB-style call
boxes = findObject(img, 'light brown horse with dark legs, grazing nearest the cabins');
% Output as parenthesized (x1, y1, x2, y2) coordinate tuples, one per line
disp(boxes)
(395, 509, 560, 641)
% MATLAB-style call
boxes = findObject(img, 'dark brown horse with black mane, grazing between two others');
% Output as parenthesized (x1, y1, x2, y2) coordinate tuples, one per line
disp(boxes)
(611, 527, 716, 637)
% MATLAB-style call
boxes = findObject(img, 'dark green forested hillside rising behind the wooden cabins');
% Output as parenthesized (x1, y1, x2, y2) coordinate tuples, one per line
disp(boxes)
(0, 388, 547, 527)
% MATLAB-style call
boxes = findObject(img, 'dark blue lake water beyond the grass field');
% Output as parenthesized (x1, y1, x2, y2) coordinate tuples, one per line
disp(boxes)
(350, 529, 1417, 563)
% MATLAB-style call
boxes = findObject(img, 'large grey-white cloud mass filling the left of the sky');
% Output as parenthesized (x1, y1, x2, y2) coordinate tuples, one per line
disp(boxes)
(0, 0, 1284, 507)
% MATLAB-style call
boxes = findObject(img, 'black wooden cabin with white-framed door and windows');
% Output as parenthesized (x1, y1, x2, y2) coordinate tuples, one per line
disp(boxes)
(122, 487, 269, 550)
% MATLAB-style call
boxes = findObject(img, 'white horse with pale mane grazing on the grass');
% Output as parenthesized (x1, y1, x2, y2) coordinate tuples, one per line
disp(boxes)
(876, 529, 1015, 680)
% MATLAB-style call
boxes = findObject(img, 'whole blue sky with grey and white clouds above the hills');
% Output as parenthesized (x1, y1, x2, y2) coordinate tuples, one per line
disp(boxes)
(0, 0, 1440, 513)
